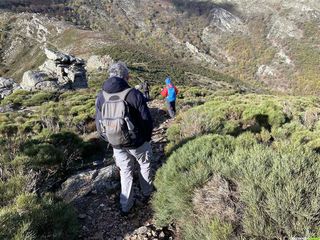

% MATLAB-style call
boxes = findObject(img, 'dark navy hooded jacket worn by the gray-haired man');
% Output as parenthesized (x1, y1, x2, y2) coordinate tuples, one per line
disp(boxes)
(96, 77, 153, 149)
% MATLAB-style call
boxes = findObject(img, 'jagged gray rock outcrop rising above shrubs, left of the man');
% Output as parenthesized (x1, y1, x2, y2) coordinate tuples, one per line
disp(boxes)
(21, 49, 88, 90)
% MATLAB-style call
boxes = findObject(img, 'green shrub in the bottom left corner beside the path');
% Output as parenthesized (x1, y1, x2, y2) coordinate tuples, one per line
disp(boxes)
(0, 194, 78, 240)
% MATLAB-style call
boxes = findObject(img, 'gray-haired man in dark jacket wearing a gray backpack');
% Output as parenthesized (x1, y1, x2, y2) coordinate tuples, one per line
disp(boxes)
(96, 62, 153, 215)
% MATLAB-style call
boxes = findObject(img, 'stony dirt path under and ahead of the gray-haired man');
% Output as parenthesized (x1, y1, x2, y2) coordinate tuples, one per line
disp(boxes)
(73, 100, 174, 240)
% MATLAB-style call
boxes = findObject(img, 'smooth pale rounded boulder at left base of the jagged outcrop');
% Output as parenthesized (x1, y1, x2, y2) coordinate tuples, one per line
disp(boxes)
(21, 71, 58, 91)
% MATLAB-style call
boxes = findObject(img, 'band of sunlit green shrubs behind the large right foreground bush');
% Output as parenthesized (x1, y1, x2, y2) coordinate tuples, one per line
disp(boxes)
(168, 94, 319, 146)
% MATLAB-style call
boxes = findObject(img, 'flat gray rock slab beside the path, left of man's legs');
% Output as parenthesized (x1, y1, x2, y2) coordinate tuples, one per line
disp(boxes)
(57, 165, 120, 202)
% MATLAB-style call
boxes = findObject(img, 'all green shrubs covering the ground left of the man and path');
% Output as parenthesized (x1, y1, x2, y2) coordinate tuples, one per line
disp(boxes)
(0, 86, 105, 240)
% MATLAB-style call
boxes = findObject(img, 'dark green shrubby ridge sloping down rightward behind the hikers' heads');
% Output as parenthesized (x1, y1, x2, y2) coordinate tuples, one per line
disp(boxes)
(97, 45, 243, 88)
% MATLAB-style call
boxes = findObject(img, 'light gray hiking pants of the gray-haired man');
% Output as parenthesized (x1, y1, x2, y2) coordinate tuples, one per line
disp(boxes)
(113, 142, 153, 212)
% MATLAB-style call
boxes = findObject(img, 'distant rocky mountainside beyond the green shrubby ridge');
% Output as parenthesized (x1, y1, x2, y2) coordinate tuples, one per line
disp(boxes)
(0, 0, 320, 94)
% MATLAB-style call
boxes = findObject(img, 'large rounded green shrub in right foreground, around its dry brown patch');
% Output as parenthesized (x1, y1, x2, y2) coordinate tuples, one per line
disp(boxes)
(153, 133, 320, 239)
